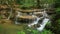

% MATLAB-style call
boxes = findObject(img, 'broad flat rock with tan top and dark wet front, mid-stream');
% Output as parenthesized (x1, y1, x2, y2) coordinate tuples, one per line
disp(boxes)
(17, 16, 36, 23)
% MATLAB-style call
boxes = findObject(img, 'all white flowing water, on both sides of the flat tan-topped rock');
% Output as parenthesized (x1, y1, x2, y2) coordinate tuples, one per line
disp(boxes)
(15, 10, 49, 31)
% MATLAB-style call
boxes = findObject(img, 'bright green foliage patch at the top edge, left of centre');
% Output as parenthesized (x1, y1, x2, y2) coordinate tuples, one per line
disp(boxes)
(16, 0, 35, 7)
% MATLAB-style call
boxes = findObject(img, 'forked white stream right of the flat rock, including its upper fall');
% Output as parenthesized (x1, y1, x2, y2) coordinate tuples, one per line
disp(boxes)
(28, 10, 49, 31)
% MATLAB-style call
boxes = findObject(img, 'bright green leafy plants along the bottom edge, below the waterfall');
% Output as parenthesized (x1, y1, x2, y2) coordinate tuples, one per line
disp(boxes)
(18, 28, 53, 34)
